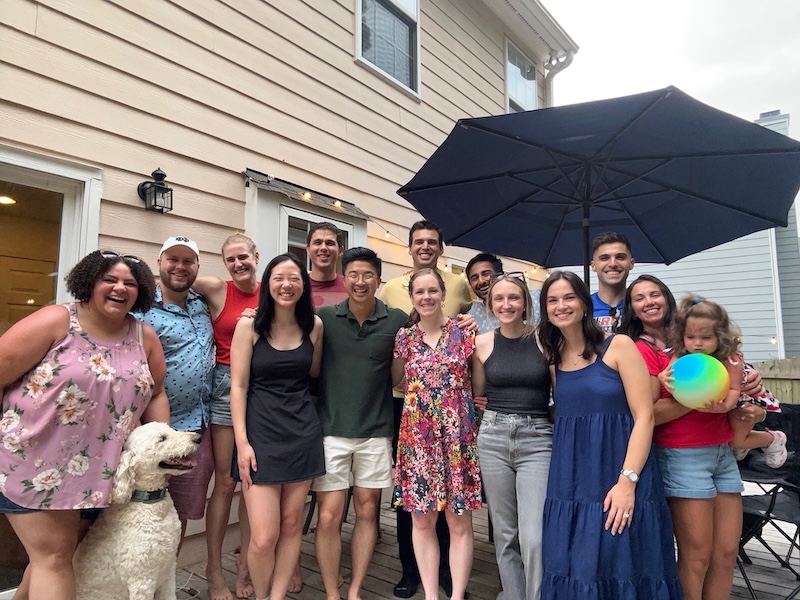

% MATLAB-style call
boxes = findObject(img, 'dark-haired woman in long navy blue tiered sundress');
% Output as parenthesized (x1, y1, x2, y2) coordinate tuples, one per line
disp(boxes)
(539, 271, 682, 600)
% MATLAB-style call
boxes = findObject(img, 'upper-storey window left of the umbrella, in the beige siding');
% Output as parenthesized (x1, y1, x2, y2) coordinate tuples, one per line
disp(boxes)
(356, 0, 419, 92)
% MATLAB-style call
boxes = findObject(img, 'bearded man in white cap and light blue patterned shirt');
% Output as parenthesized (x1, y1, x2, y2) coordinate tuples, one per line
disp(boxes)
(143, 237, 214, 540)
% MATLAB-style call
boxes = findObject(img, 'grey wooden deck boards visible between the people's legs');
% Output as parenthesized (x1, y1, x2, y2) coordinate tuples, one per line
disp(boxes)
(177, 490, 800, 600)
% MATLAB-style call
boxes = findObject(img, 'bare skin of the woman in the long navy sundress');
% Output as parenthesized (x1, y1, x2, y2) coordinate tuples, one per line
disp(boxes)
(547, 279, 654, 535)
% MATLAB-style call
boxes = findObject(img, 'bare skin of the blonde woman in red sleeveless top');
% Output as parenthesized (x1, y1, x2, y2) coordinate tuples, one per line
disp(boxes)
(193, 243, 259, 600)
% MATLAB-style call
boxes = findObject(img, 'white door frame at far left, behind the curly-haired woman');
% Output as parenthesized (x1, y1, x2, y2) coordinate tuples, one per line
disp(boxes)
(0, 144, 103, 303)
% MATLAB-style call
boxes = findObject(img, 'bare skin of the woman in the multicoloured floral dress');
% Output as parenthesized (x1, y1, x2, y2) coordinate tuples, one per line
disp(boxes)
(392, 275, 473, 600)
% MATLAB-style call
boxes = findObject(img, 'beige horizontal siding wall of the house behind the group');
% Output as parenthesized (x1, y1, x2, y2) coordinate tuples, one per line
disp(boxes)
(0, 0, 544, 277)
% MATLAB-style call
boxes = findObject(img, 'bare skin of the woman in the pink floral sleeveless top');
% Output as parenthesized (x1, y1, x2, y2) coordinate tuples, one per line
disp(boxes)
(0, 262, 169, 600)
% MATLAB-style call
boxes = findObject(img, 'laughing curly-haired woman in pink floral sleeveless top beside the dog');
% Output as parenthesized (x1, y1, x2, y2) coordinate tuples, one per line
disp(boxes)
(0, 251, 169, 600)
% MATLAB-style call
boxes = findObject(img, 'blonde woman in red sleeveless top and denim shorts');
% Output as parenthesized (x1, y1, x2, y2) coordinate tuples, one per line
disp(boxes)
(193, 233, 259, 600)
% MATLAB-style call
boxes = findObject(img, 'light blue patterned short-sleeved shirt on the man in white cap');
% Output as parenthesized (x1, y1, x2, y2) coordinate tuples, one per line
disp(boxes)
(143, 288, 214, 431)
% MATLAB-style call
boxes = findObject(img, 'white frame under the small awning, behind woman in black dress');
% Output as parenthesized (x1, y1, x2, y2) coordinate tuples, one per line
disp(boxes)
(245, 183, 367, 276)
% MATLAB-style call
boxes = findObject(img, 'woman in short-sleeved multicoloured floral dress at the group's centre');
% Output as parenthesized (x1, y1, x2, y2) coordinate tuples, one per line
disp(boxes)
(392, 269, 481, 600)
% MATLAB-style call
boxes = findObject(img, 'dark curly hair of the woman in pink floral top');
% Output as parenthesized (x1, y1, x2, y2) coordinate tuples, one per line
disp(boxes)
(65, 250, 156, 313)
